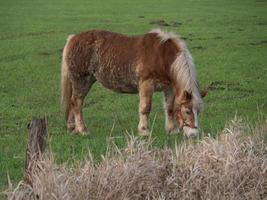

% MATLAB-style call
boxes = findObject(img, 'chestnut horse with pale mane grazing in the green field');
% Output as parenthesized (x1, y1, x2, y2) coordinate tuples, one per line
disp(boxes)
(61, 29, 207, 136)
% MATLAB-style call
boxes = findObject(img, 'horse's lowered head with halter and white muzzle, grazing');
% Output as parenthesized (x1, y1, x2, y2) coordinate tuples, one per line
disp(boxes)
(174, 91, 207, 137)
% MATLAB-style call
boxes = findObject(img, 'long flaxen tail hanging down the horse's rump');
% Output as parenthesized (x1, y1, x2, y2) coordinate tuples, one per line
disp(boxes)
(61, 35, 73, 121)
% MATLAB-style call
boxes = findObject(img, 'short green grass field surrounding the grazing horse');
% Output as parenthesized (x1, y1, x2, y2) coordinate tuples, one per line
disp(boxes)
(0, 0, 267, 194)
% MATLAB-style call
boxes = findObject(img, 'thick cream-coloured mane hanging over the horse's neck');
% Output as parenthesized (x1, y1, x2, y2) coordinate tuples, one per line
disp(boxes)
(150, 29, 203, 108)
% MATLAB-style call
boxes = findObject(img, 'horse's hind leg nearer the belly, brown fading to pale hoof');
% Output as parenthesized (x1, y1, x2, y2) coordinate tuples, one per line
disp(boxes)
(71, 76, 96, 134)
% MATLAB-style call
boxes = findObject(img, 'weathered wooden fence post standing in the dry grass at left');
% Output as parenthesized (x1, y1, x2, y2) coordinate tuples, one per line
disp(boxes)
(23, 117, 47, 185)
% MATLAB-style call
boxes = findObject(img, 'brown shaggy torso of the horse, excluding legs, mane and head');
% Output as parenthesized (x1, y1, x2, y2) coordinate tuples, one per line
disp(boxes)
(64, 30, 179, 93)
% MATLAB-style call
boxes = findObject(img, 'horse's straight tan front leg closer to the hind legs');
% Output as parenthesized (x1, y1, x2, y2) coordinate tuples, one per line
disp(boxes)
(138, 80, 154, 135)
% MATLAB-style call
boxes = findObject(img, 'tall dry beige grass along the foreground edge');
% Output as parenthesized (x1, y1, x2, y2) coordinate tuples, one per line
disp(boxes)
(5, 118, 267, 200)
